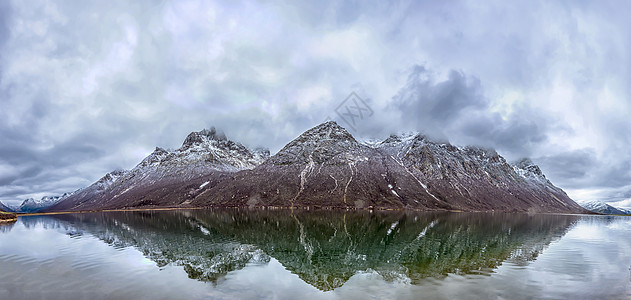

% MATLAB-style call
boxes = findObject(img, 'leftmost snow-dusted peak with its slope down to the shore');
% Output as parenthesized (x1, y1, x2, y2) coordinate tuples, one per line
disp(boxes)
(47, 127, 269, 211)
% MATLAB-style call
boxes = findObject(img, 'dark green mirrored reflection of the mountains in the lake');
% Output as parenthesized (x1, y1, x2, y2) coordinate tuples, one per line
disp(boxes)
(54, 210, 578, 291)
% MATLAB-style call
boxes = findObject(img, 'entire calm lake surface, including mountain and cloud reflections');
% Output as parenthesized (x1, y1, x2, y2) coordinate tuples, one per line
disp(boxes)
(0, 210, 631, 300)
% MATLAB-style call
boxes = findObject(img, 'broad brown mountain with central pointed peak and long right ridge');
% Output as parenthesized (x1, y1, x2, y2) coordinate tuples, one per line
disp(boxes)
(190, 121, 586, 213)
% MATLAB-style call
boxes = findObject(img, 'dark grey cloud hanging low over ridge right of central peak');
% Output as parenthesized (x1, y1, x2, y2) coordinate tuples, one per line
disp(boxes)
(390, 66, 552, 156)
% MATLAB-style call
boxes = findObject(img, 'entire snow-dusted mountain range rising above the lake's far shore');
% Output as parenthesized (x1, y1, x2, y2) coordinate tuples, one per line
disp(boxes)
(44, 121, 587, 213)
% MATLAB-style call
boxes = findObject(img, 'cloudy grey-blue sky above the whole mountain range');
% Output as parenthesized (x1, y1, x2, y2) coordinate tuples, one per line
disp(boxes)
(0, 0, 631, 207)
